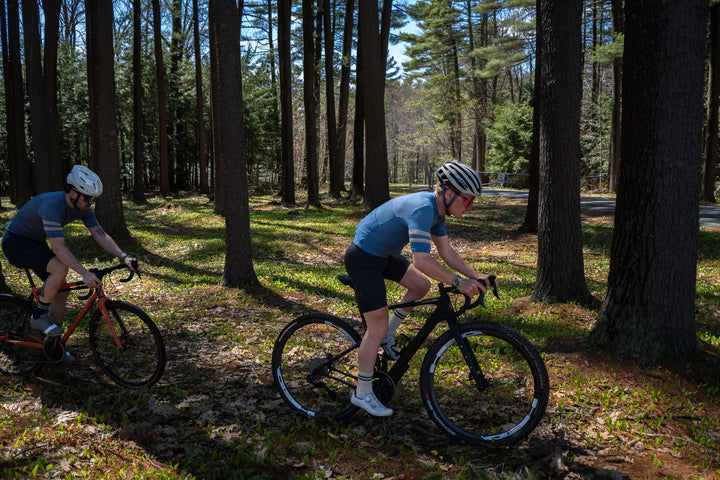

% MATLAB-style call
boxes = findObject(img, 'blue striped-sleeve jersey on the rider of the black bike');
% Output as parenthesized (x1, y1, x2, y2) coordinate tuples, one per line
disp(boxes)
(353, 192, 447, 257)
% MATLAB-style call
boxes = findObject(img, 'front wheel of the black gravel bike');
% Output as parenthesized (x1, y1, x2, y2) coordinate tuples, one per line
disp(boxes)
(420, 321, 550, 446)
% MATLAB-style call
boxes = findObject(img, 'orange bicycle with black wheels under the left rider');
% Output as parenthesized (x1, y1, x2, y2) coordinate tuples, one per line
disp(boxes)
(0, 262, 166, 388)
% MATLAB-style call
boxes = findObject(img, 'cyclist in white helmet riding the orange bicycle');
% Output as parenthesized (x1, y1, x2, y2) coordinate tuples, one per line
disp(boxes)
(2, 165, 133, 342)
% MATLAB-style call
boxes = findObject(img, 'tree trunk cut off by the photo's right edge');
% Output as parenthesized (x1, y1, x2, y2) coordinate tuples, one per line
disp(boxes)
(700, 3, 720, 203)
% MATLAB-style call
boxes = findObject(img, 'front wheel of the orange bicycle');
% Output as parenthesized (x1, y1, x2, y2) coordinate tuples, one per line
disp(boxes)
(90, 300, 166, 388)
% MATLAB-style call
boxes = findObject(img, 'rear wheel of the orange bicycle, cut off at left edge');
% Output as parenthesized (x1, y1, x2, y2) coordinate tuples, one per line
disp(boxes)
(0, 294, 43, 377)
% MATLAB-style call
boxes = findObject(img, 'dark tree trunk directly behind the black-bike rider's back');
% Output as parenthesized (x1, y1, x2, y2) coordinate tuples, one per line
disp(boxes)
(358, 0, 390, 210)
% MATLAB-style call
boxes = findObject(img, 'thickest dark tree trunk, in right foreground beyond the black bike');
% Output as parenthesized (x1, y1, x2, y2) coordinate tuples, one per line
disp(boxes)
(589, 0, 708, 365)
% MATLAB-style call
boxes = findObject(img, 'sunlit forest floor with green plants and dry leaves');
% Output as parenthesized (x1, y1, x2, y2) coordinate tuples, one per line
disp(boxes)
(0, 192, 720, 480)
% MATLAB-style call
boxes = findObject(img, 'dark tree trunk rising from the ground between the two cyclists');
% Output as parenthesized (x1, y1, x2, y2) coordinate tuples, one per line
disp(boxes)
(210, 0, 258, 287)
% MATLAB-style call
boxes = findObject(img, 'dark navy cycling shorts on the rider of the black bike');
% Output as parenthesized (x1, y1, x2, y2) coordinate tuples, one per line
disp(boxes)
(345, 244, 410, 313)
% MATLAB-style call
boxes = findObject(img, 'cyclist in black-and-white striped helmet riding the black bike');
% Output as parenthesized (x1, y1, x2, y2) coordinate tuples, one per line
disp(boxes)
(345, 161, 487, 417)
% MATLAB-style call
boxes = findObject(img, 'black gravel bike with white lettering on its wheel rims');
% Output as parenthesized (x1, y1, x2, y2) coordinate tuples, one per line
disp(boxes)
(272, 275, 550, 446)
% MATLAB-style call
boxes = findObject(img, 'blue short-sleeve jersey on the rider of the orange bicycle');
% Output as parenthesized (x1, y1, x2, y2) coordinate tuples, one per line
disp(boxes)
(6, 192, 99, 242)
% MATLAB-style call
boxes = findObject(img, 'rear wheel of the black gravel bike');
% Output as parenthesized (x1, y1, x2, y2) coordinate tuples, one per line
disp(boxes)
(272, 313, 361, 419)
